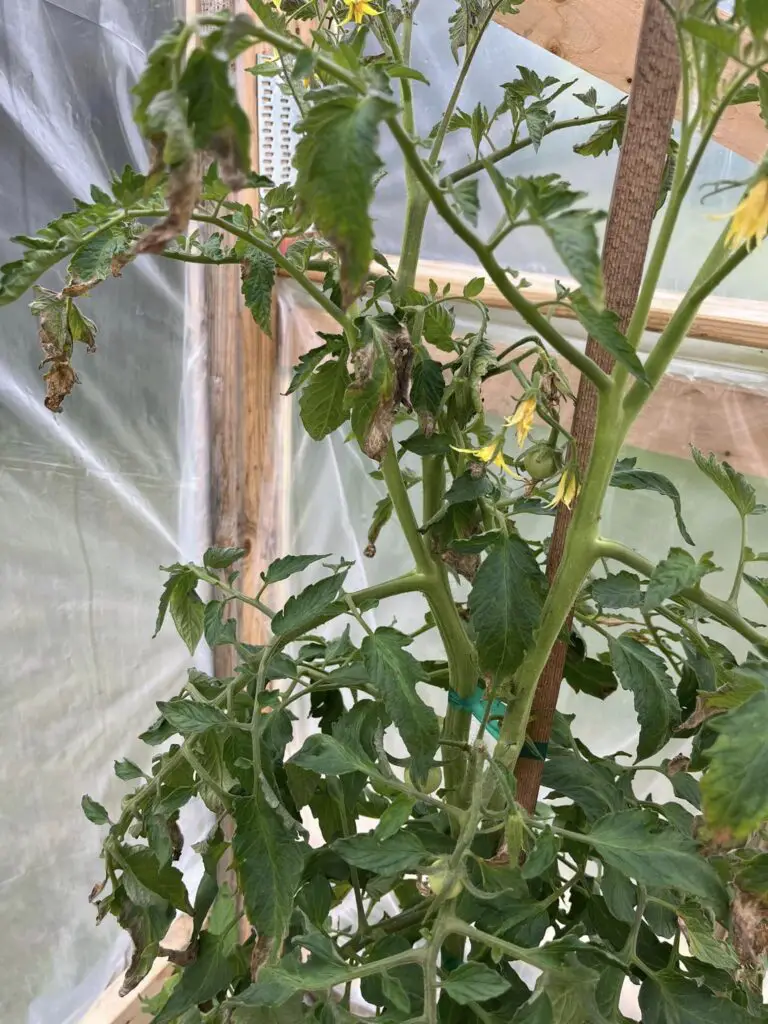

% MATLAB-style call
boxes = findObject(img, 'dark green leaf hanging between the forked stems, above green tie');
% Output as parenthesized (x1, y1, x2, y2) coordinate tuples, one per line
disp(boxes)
(469, 537, 547, 680)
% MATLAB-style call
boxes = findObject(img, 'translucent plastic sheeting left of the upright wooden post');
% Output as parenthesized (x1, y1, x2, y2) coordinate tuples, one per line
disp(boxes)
(0, 0, 207, 1024)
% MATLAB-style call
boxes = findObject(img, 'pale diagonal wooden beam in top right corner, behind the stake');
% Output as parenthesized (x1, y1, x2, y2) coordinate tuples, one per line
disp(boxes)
(496, 0, 768, 163)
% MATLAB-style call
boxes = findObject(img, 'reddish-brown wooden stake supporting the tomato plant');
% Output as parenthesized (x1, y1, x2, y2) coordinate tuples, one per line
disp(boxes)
(516, 0, 680, 812)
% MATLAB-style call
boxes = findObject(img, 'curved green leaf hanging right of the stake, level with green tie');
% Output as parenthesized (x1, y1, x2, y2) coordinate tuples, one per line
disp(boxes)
(609, 635, 680, 761)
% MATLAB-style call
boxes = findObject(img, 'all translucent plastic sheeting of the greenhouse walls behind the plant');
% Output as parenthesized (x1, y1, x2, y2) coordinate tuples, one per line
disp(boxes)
(0, 0, 768, 1024)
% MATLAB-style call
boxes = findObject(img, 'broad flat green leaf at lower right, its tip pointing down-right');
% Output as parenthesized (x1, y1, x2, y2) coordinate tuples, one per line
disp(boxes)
(587, 809, 725, 908)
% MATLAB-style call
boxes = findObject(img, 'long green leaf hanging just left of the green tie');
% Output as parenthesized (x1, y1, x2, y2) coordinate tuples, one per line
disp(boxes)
(360, 627, 439, 776)
